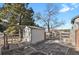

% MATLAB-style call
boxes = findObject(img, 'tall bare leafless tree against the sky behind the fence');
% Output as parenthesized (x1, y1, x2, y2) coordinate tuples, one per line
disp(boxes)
(35, 4, 64, 32)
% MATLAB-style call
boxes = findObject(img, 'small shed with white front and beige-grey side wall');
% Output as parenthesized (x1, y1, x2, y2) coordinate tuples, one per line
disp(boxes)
(23, 26, 45, 44)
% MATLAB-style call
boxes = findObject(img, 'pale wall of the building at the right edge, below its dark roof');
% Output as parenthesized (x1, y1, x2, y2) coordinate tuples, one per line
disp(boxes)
(71, 18, 79, 47)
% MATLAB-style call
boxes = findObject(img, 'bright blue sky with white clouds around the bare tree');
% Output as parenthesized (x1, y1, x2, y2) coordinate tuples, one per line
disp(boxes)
(0, 3, 79, 29)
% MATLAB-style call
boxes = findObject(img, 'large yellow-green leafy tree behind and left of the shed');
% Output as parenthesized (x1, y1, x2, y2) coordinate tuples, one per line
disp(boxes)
(0, 3, 35, 34)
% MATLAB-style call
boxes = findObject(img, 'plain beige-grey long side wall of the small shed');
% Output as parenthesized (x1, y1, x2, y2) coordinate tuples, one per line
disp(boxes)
(31, 29, 45, 44)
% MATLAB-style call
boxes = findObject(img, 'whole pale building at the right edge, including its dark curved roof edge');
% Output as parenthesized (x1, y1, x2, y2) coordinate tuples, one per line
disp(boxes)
(71, 16, 79, 50)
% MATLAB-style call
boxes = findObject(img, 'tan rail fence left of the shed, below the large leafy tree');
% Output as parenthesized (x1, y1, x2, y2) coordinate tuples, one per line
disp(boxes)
(0, 33, 20, 46)
